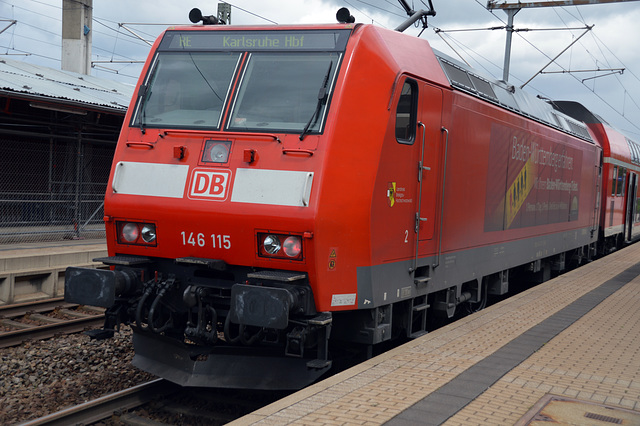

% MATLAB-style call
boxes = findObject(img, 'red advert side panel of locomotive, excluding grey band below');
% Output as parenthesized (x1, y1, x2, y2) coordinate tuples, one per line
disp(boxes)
(444, 95, 598, 246)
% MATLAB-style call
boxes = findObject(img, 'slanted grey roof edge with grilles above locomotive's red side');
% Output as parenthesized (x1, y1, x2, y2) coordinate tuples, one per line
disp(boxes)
(434, 49, 593, 142)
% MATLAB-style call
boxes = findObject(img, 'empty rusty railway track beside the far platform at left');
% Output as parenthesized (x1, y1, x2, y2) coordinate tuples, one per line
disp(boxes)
(0, 297, 104, 348)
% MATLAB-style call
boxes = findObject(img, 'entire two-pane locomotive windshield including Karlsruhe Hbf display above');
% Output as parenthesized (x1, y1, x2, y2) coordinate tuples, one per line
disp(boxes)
(130, 28, 351, 133)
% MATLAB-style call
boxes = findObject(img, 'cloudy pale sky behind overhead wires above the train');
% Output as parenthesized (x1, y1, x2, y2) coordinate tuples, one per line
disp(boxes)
(0, 0, 640, 136)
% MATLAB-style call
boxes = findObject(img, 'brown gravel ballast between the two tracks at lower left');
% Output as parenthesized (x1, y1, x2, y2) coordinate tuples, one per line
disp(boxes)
(0, 327, 155, 425)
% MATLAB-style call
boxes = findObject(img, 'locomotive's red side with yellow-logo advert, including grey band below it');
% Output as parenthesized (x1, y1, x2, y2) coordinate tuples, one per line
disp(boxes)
(435, 90, 598, 285)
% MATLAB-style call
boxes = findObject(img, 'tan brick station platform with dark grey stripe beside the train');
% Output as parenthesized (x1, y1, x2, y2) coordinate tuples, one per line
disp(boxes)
(231, 244, 640, 426)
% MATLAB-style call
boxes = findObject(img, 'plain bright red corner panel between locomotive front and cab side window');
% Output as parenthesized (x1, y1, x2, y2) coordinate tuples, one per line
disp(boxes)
(314, 27, 402, 312)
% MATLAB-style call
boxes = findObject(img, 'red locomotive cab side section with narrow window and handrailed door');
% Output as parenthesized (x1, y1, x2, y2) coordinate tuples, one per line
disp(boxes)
(371, 76, 443, 264)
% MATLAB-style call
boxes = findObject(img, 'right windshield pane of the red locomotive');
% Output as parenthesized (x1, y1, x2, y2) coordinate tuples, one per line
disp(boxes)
(228, 52, 340, 132)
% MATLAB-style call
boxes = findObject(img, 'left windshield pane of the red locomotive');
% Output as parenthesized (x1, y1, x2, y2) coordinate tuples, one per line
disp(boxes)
(133, 52, 240, 129)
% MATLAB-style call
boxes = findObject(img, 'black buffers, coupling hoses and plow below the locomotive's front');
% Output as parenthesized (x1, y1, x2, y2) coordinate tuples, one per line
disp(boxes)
(65, 256, 332, 389)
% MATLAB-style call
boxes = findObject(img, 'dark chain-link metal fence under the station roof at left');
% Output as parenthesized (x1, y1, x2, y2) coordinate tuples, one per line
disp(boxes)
(0, 135, 115, 244)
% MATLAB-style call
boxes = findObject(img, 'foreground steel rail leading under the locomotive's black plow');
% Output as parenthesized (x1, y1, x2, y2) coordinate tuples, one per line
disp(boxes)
(21, 379, 182, 426)
